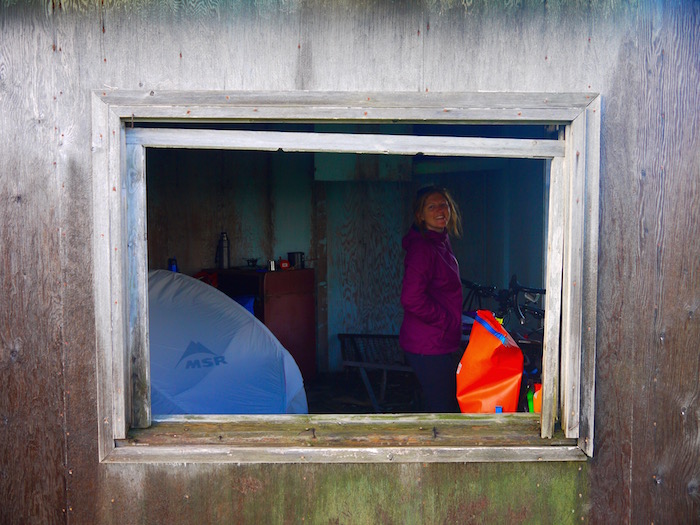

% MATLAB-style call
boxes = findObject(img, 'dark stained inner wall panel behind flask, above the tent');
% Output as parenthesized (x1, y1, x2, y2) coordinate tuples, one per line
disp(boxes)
(147, 150, 276, 275)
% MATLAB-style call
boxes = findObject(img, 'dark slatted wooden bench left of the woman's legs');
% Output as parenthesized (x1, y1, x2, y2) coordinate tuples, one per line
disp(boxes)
(338, 334, 413, 413)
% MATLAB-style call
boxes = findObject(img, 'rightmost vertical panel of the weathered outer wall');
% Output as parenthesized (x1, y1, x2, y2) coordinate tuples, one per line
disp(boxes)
(630, 4, 700, 523)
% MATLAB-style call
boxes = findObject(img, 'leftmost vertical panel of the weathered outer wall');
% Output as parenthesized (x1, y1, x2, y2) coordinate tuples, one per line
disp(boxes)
(0, 6, 68, 524)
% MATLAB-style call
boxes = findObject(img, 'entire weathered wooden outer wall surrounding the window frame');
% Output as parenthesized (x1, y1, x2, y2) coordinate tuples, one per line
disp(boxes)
(0, 0, 700, 523)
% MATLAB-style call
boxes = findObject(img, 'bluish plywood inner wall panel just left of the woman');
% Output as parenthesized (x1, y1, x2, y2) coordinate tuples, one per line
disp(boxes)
(325, 182, 412, 369)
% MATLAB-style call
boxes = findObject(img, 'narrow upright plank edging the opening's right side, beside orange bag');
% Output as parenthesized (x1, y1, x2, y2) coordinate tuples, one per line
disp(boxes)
(541, 157, 567, 438)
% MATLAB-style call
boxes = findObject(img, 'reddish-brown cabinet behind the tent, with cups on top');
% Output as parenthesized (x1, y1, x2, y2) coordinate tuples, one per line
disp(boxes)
(207, 268, 316, 381)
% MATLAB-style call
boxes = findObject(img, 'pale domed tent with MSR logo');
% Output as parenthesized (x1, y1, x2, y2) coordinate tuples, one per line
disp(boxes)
(148, 270, 308, 415)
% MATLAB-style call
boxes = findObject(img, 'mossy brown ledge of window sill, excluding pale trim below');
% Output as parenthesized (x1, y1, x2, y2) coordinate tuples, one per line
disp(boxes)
(119, 414, 575, 448)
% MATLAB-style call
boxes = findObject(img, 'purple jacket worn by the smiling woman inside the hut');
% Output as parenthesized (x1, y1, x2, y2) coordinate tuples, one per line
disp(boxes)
(399, 226, 462, 355)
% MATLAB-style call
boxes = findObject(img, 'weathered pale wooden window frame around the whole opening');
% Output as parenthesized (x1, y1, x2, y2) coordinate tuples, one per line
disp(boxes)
(92, 91, 601, 463)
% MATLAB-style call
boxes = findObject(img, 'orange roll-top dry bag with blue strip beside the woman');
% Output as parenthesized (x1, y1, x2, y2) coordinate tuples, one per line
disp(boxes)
(457, 310, 523, 413)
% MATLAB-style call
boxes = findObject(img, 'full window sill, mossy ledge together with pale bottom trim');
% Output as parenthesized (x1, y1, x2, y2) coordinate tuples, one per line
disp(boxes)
(104, 414, 586, 463)
